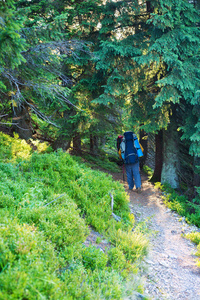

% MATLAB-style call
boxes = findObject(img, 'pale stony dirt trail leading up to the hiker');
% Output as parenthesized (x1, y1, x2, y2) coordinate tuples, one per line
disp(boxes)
(113, 174, 200, 300)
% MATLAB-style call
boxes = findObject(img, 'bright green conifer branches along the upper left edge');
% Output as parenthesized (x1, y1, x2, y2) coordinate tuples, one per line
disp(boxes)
(0, 0, 25, 124)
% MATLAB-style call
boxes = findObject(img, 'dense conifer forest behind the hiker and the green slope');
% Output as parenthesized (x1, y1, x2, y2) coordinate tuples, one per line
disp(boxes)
(0, 0, 200, 200)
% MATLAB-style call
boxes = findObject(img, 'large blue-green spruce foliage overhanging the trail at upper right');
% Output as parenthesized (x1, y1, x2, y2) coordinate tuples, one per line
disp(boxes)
(91, 0, 200, 187)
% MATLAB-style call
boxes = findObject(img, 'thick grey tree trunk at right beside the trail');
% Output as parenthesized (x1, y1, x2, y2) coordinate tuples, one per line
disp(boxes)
(161, 113, 180, 189)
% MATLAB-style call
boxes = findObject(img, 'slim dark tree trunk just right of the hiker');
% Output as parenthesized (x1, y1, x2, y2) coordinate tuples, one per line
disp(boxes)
(150, 130, 163, 182)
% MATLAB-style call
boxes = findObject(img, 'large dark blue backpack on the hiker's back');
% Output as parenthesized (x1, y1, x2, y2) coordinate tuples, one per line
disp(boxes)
(120, 131, 139, 164)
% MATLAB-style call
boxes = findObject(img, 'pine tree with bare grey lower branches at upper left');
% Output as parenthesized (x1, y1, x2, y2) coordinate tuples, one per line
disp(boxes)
(1, 1, 89, 143)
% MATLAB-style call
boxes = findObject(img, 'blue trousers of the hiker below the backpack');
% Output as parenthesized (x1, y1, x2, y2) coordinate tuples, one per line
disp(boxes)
(125, 162, 141, 190)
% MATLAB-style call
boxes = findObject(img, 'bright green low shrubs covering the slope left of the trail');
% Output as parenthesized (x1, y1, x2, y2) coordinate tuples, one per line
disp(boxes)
(0, 134, 148, 300)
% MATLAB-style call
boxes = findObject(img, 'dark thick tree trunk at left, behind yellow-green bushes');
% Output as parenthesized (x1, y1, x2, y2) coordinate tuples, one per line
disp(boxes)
(12, 105, 33, 140)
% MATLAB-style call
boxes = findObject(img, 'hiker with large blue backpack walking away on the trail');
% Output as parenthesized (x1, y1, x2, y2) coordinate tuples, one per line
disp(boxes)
(119, 131, 143, 193)
